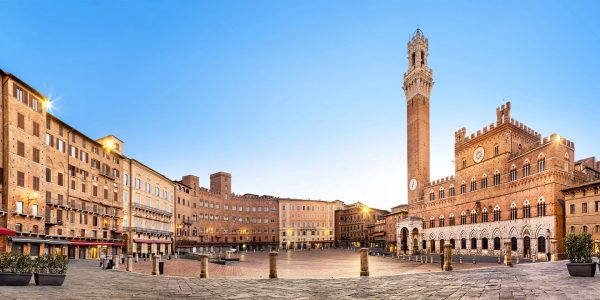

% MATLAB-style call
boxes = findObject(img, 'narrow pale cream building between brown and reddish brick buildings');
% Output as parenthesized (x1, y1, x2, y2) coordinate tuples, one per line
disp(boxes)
(123, 158, 175, 257)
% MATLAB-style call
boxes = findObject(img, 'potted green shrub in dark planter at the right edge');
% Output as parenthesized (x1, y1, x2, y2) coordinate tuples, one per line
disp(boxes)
(565, 232, 596, 277)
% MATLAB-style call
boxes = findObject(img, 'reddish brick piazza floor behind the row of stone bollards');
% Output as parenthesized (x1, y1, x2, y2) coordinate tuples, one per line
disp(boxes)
(133, 249, 497, 279)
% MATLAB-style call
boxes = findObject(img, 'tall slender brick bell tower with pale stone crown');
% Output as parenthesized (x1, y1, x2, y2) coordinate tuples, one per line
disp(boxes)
(403, 28, 433, 204)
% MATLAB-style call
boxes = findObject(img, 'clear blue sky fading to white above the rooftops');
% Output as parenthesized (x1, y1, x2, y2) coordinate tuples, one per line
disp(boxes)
(0, 0, 600, 209)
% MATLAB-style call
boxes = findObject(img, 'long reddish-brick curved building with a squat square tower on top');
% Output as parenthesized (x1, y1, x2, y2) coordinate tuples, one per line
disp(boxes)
(176, 172, 279, 252)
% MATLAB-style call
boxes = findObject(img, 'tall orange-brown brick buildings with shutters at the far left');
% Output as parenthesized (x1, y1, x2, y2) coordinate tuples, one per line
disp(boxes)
(0, 70, 123, 258)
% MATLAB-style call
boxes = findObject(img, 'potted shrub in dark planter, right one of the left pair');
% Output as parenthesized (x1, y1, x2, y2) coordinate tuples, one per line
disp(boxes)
(33, 254, 69, 286)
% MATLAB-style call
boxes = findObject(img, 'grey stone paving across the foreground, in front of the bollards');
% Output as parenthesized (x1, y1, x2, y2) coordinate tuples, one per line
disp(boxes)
(0, 250, 600, 299)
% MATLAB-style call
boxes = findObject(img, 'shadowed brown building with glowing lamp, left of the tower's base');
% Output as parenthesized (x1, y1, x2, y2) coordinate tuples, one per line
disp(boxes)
(335, 202, 389, 247)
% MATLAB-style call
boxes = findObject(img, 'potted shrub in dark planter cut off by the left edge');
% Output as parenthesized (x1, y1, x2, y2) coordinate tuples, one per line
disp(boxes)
(0, 253, 33, 286)
